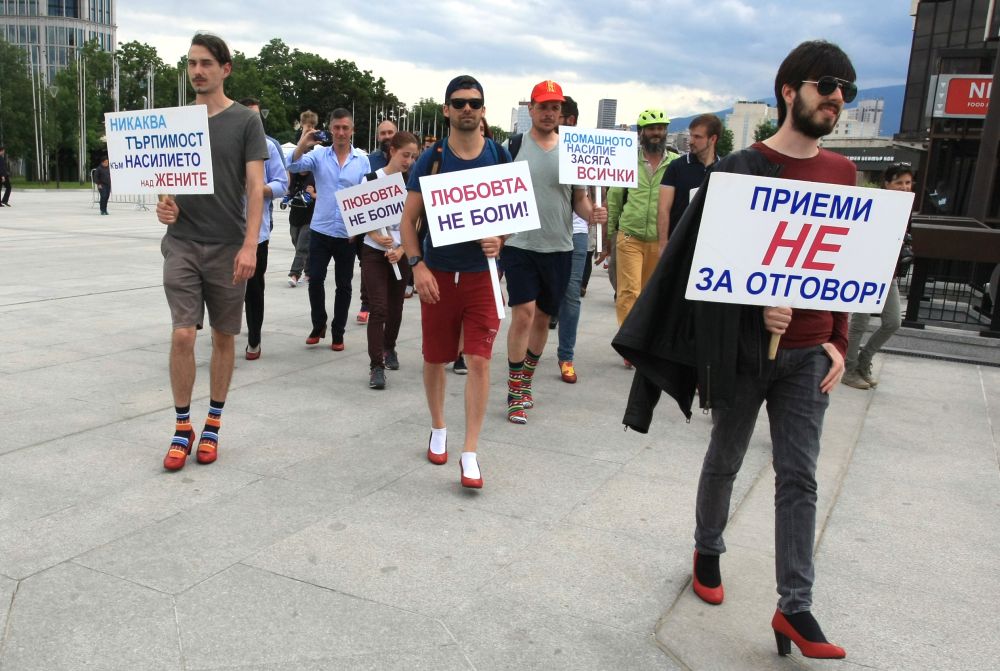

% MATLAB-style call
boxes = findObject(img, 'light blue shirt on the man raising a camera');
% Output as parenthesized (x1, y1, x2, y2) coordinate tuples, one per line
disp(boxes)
(288, 147, 372, 238)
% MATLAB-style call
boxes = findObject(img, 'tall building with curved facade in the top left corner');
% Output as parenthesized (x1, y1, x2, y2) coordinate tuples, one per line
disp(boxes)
(0, 0, 117, 81)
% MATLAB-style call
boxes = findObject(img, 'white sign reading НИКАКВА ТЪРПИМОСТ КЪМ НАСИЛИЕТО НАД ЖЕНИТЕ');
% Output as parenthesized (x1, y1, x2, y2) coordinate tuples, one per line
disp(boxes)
(104, 105, 215, 194)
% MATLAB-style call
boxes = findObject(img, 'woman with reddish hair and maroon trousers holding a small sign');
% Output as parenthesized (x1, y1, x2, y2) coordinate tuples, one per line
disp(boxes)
(361, 131, 420, 389)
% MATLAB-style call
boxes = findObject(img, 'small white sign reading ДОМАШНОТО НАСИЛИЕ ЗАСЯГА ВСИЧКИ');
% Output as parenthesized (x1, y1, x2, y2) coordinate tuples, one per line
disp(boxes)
(559, 126, 639, 189)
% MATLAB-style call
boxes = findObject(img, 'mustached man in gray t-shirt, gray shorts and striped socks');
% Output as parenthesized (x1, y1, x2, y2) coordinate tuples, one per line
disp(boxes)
(156, 33, 268, 471)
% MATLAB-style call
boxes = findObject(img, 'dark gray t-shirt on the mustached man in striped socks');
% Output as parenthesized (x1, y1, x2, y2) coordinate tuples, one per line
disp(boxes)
(167, 103, 268, 244)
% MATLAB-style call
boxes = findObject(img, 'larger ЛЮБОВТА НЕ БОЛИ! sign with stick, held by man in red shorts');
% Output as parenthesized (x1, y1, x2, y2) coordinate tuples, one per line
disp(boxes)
(420, 161, 542, 319)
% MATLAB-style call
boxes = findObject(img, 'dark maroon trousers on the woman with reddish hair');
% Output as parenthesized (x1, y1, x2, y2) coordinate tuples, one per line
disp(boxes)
(361, 245, 410, 367)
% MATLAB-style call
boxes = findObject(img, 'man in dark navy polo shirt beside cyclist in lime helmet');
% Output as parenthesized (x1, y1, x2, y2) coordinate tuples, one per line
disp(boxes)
(656, 114, 722, 254)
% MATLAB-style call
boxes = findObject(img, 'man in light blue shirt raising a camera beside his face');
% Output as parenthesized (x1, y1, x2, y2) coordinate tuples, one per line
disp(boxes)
(288, 108, 371, 352)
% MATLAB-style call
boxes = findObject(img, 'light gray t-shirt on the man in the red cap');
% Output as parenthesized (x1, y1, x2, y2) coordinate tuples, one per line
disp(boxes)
(504, 132, 573, 253)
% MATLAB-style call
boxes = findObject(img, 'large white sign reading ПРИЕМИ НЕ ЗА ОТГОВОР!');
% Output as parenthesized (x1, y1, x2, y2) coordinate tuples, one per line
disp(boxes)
(685, 172, 913, 314)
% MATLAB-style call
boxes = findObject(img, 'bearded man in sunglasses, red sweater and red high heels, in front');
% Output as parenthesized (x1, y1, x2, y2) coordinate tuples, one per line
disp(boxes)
(612, 41, 857, 658)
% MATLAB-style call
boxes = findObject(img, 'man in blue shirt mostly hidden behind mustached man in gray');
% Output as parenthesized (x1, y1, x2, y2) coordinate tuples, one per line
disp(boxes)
(240, 98, 288, 361)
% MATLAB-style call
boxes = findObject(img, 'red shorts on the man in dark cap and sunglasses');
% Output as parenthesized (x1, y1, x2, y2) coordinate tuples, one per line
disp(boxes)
(420, 269, 500, 363)
